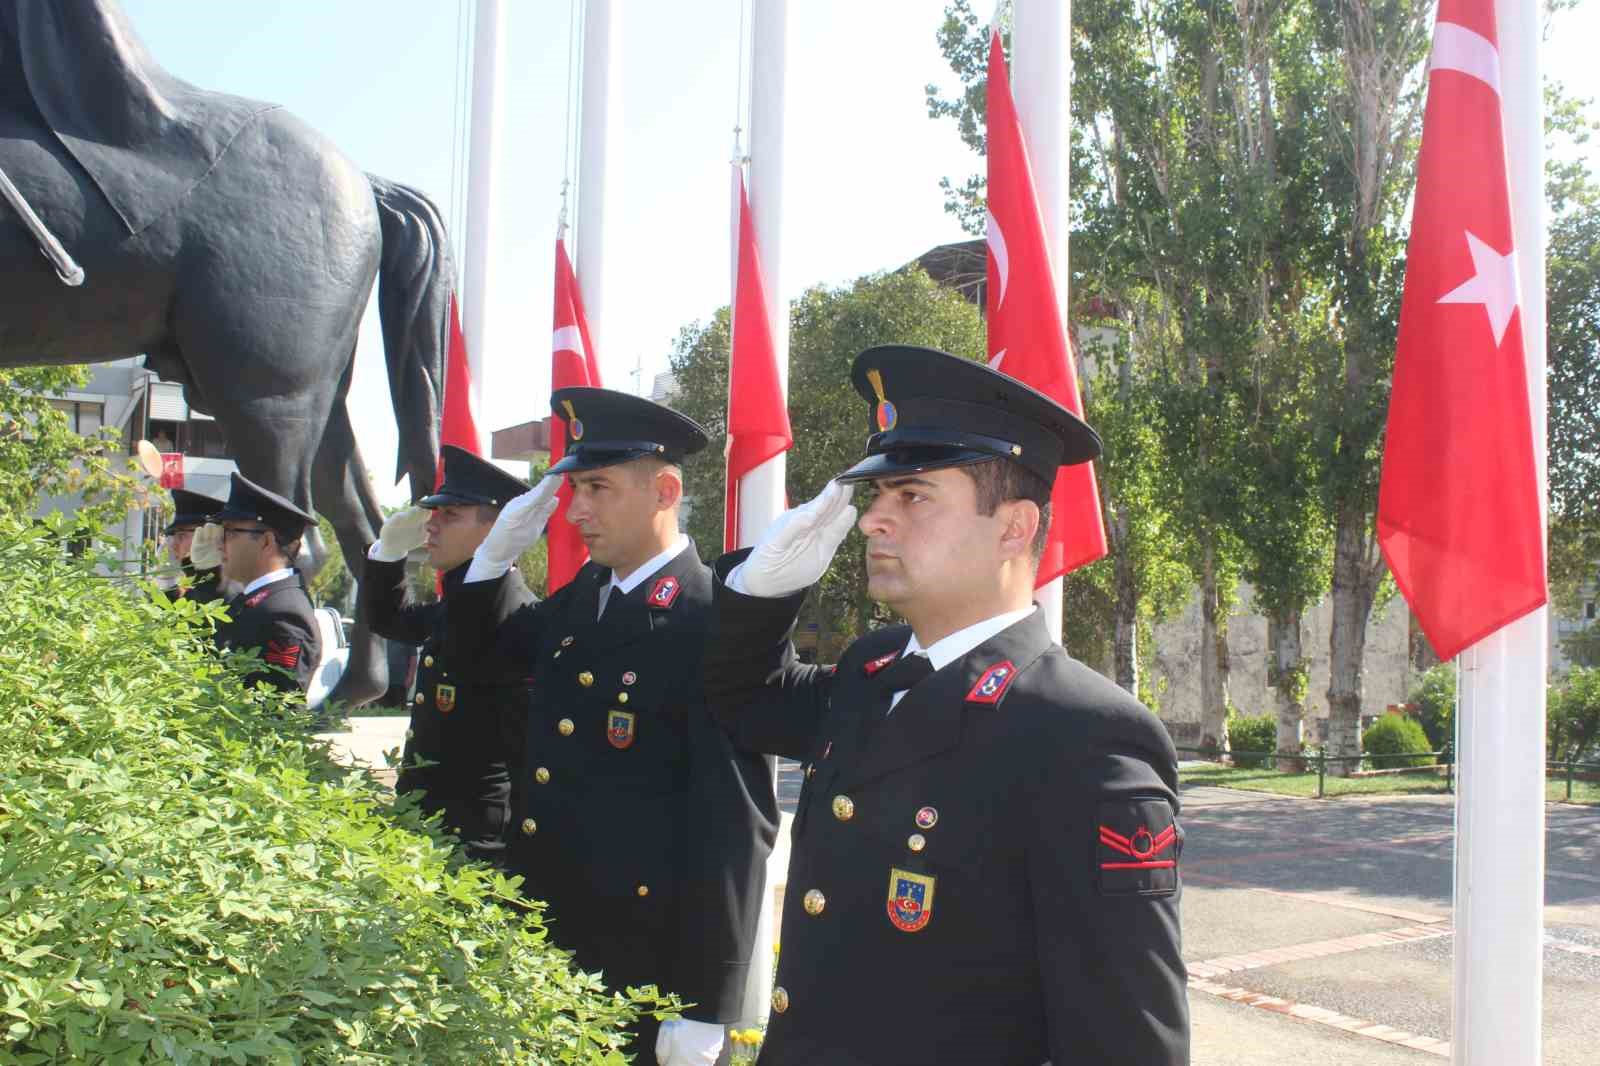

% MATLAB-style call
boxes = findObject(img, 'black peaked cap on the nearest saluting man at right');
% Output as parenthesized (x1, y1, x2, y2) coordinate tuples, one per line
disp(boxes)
(838, 344, 1101, 483)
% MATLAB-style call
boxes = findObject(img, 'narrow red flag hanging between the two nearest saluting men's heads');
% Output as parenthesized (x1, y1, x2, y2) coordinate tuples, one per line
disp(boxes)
(722, 163, 795, 552)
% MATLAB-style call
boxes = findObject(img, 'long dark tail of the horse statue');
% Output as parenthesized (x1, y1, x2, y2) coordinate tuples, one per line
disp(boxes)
(366, 174, 456, 499)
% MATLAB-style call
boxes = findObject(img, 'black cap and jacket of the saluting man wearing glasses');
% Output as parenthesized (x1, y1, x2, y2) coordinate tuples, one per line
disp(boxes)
(214, 474, 322, 693)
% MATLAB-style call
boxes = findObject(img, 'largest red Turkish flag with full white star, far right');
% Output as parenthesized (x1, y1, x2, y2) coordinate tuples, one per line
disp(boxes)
(1378, 0, 1547, 659)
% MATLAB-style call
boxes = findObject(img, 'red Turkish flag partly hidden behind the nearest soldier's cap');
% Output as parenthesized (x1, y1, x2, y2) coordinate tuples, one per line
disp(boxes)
(987, 30, 1106, 587)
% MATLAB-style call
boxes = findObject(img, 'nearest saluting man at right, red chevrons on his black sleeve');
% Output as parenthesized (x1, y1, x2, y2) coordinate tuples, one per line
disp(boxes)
(706, 347, 1189, 1066)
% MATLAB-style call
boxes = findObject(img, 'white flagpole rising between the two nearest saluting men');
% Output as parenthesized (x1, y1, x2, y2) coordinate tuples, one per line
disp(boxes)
(733, 0, 789, 1021)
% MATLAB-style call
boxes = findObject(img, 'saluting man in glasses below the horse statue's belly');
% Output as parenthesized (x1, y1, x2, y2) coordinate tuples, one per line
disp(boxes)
(214, 474, 322, 693)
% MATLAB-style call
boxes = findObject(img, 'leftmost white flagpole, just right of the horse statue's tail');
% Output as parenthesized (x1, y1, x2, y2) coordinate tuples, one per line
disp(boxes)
(462, 0, 501, 450)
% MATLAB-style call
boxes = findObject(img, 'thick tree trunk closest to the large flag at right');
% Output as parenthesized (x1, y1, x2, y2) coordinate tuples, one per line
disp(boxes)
(1328, 499, 1382, 776)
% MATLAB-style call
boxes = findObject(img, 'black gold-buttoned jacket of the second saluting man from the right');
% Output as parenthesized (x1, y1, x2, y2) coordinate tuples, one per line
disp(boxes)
(445, 544, 778, 1021)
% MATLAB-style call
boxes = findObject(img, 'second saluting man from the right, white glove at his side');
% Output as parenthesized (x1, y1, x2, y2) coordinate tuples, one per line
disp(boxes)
(445, 389, 778, 1066)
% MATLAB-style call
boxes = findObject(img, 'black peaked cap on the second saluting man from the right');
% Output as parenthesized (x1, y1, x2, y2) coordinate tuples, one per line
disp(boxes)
(549, 386, 709, 474)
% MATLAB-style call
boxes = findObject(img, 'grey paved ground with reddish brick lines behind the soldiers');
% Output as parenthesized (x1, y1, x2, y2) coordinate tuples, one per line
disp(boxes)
(315, 719, 1600, 1066)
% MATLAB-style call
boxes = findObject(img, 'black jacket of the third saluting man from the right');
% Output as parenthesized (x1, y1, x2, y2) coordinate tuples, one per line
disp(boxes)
(360, 559, 536, 860)
